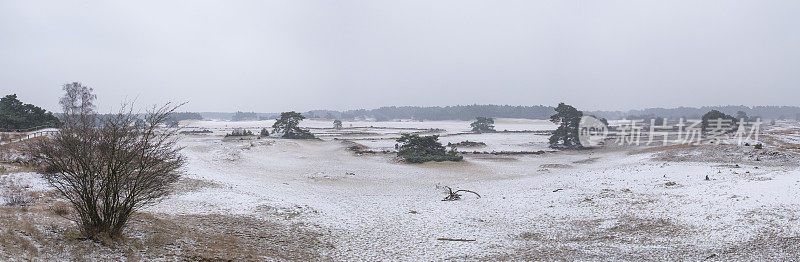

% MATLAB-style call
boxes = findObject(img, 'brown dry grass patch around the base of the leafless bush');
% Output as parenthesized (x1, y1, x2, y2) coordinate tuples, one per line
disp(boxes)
(0, 192, 332, 261)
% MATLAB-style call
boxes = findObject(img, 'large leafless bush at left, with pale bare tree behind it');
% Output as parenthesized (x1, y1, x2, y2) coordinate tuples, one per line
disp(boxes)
(28, 83, 184, 239)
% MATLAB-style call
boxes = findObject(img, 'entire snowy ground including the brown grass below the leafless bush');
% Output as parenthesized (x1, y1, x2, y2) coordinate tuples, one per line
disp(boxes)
(0, 119, 800, 261)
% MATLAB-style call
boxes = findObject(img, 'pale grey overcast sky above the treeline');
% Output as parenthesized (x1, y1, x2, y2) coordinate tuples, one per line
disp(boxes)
(0, 0, 800, 112)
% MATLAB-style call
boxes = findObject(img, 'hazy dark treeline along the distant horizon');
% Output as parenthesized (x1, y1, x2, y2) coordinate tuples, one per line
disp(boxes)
(199, 105, 800, 121)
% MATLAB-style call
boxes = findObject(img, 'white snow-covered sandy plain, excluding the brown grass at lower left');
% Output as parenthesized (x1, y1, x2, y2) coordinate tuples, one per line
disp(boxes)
(134, 120, 800, 260)
